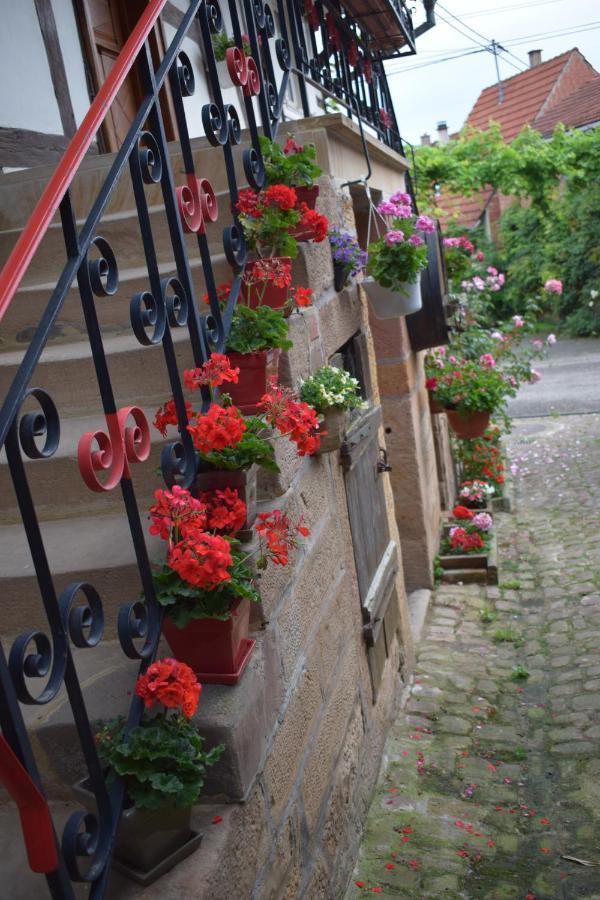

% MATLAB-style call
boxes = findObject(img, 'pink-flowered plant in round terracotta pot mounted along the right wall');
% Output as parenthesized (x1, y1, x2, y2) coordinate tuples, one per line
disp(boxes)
(434, 354, 516, 439)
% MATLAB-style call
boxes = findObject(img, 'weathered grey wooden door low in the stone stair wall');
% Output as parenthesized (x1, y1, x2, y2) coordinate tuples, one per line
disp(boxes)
(342, 406, 399, 699)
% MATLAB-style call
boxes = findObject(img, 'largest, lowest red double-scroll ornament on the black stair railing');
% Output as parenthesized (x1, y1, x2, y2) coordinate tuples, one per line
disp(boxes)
(77, 406, 150, 493)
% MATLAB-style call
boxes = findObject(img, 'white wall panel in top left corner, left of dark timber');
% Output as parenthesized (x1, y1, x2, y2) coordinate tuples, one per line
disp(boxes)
(0, 0, 63, 134)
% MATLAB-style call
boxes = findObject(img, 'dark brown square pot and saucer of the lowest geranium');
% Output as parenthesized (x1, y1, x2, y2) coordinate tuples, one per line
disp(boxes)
(73, 779, 202, 884)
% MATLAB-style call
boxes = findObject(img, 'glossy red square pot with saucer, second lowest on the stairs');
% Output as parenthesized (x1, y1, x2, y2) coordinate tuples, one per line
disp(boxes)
(162, 598, 256, 684)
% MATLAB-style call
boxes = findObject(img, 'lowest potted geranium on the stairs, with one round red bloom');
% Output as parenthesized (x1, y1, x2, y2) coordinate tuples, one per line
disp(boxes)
(74, 659, 225, 884)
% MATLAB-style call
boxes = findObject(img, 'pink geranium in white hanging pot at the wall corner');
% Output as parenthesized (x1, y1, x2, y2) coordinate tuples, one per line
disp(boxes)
(363, 191, 428, 319)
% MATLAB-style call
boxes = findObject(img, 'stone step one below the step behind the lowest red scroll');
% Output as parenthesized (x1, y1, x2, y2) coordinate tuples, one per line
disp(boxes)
(0, 512, 165, 640)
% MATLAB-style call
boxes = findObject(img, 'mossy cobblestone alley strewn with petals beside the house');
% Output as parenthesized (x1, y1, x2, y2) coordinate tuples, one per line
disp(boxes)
(348, 415, 600, 900)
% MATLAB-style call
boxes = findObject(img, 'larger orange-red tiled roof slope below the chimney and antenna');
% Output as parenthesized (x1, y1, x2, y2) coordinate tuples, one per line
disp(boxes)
(467, 50, 580, 141)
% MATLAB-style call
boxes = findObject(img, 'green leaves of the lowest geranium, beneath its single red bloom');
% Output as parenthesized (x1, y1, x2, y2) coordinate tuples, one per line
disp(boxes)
(97, 716, 225, 809)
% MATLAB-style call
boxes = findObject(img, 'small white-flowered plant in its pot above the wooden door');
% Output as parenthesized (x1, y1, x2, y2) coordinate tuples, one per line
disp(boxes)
(300, 366, 364, 453)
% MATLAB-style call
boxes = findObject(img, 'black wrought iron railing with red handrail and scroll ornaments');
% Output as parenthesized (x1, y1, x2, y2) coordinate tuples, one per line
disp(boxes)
(0, 0, 414, 900)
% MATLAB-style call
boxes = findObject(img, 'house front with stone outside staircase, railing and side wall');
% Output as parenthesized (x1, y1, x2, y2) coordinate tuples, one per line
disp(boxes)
(0, 0, 453, 900)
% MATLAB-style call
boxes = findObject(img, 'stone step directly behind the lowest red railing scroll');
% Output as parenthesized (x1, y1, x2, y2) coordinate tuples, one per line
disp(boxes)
(0, 407, 169, 525)
